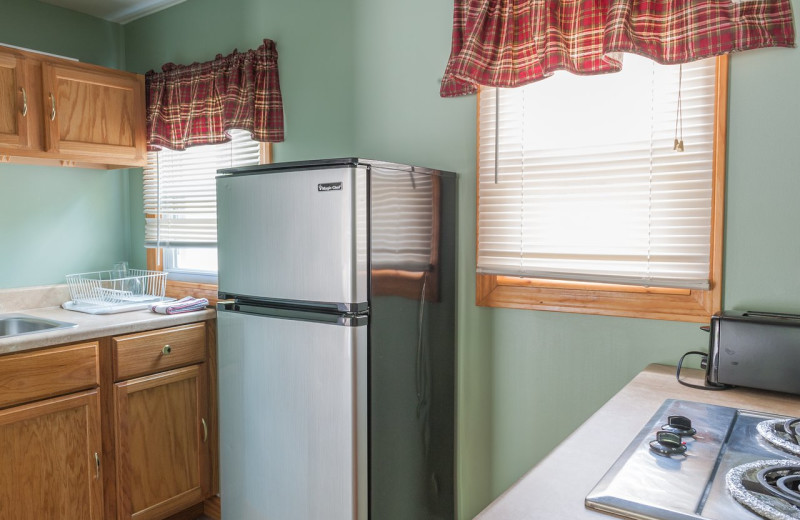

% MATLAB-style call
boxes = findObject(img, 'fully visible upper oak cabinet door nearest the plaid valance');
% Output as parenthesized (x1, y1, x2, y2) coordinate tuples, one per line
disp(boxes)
(42, 62, 145, 166)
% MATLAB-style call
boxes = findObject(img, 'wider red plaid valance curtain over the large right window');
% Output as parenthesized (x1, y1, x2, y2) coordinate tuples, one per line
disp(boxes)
(441, 0, 794, 97)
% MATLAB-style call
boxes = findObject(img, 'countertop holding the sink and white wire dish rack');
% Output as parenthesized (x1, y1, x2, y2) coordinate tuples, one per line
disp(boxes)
(0, 286, 216, 355)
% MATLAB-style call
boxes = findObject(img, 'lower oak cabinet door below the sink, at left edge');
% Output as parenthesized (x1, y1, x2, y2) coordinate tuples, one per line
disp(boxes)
(0, 390, 103, 520)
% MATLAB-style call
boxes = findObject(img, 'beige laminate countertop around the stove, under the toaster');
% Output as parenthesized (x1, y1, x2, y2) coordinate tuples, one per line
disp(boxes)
(475, 365, 800, 520)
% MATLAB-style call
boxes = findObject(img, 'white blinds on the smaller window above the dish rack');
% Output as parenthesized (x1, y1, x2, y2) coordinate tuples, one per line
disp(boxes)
(144, 130, 260, 247)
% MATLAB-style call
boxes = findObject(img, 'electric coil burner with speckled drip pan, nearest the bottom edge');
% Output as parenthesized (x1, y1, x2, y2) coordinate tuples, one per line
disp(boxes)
(725, 460, 800, 520)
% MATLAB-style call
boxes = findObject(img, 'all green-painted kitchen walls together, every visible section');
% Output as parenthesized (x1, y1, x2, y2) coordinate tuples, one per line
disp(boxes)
(0, 0, 800, 519)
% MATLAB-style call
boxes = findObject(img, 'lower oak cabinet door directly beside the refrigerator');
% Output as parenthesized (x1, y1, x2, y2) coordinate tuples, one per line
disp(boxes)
(114, 364, 210, 520)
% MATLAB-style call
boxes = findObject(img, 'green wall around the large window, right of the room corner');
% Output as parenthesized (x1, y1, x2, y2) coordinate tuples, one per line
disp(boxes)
(355, 0, 800, 518)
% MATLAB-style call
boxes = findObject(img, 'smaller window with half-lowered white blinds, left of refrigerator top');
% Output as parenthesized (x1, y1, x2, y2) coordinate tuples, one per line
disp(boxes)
(144, 130, 268, 295)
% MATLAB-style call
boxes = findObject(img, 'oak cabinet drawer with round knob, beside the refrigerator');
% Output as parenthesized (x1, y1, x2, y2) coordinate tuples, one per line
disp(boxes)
(111, 323, 206, 381)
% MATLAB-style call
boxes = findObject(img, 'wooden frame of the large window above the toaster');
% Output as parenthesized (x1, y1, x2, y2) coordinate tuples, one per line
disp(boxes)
(475, 55, 728, 323)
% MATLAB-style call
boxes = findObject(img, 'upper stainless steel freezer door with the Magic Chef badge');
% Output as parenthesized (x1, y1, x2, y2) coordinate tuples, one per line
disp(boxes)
(217, 166, 367, 311)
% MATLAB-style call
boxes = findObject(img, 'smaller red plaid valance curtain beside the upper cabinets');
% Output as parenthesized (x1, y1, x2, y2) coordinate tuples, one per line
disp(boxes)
(145, 40, 283, 150)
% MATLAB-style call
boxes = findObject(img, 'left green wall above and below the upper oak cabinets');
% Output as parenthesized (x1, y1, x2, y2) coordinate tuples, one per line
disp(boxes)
(0, 0, 130, 288)
